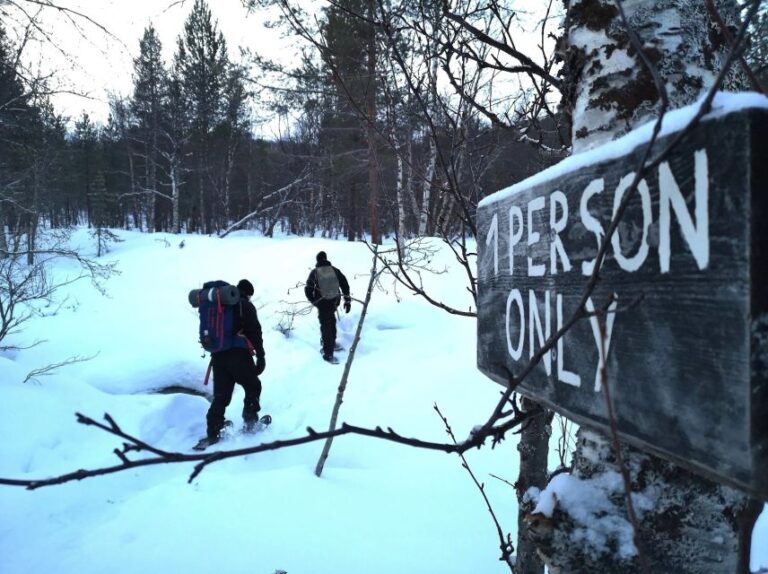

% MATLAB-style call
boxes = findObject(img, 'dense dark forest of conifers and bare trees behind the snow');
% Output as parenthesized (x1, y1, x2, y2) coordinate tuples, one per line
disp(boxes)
(0, 0, 566, 252)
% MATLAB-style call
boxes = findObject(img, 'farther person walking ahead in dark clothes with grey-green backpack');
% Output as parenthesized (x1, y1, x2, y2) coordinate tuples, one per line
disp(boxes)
(304, 251, 352, 363)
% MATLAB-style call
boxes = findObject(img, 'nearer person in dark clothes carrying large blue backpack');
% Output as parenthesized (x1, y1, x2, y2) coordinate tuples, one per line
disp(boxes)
(190, 279, 266, 449)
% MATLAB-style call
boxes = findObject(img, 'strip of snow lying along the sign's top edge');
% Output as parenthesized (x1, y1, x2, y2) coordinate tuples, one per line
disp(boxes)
(478, 92, 768, 207)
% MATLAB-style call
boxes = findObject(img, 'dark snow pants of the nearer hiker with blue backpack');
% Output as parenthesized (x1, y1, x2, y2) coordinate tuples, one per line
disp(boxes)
(206, 348, 261, 438)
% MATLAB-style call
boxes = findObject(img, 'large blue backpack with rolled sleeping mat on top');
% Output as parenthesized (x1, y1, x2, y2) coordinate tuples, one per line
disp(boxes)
(189, 281, 248, 353)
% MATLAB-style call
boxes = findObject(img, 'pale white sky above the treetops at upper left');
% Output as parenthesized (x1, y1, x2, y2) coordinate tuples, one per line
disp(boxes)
(8, 0, 289, 130)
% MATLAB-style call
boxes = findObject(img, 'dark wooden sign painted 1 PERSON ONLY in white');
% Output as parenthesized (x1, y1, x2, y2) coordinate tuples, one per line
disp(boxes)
(477, 108, 768, 500)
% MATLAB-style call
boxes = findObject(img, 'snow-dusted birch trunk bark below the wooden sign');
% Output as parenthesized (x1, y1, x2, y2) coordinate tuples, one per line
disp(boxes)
(529, 427, 745, 574)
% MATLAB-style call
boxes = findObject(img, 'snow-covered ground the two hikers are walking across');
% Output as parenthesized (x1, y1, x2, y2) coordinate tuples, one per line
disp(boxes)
(0, 232, 768, 574)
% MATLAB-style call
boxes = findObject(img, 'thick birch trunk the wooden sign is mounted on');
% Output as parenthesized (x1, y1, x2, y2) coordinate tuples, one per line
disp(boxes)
(537, 0, 754, 574)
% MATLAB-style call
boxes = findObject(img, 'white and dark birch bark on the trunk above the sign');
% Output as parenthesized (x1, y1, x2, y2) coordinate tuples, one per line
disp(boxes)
(566, 0, 741, 153)
